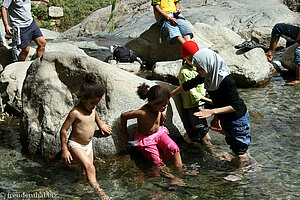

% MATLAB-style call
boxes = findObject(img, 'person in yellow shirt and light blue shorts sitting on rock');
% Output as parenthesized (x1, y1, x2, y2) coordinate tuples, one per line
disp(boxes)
(152, 0, 193, 44)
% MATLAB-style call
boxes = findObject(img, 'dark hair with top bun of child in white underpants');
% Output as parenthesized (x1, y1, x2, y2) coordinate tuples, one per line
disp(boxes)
(76, 73, 106, 98)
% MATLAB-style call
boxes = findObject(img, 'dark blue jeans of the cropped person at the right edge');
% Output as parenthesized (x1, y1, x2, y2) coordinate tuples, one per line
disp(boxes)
(272, 23, 300, 66)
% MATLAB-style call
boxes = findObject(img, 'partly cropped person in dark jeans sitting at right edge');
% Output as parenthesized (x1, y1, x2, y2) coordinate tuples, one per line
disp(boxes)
(265, 23, 300, 85)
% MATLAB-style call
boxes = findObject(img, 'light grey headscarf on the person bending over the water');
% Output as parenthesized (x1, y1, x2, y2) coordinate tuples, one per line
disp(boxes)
(192, 48, 230, 91)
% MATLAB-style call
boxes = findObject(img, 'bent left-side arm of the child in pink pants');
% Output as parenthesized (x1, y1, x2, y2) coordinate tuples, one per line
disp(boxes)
(118, 110, 141, 145)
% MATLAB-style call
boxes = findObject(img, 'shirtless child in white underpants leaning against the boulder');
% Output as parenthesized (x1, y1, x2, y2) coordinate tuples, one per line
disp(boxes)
(60, 74, 112, 200)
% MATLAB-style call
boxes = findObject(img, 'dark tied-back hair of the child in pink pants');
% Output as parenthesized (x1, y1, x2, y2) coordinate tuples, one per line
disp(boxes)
(137, 83, 171, 103)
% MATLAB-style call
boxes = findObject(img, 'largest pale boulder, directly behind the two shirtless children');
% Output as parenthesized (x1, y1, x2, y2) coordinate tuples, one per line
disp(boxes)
(22, 52, 184, 158)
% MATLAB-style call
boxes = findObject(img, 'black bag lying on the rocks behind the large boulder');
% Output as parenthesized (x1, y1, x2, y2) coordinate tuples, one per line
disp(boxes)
(113, 46, 137, 63)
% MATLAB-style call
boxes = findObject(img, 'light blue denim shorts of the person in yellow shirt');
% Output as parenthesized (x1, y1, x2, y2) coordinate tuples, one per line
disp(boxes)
(157, 13, 194, 44)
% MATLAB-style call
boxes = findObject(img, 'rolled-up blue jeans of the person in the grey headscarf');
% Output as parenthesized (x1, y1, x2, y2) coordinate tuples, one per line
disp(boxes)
(221, 111, 251, 155)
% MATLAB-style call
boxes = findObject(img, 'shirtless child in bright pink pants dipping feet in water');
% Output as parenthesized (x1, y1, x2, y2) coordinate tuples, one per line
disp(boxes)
(120, 83, 182, 185)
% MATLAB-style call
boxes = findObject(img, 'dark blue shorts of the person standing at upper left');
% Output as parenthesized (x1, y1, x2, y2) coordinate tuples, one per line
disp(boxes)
(18, 21, 43, 49)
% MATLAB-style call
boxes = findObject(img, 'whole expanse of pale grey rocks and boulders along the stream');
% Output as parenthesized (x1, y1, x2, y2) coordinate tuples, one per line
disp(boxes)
(0, 0, 300, 158)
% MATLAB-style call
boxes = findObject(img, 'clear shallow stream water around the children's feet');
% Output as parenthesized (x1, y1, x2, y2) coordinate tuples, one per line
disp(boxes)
(0, 71, 300, 199)
